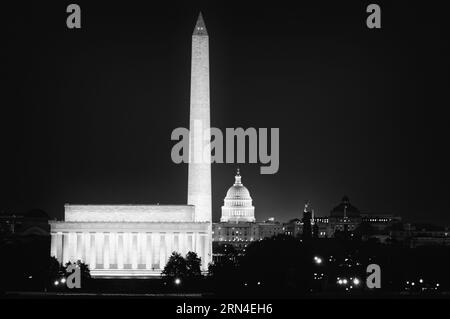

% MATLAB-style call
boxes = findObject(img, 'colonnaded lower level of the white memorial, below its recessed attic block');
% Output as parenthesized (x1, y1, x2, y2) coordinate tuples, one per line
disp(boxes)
(51, 231, 210, 275)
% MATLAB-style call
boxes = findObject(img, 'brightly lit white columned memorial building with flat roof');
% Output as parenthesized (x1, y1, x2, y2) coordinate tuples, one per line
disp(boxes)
(51, 205, 210, 276)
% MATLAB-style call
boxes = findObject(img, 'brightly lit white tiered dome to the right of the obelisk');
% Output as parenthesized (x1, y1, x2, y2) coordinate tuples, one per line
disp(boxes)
(220, 169, 255, 223)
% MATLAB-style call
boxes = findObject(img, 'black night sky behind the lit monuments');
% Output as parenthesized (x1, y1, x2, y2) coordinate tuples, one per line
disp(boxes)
(0, 1, 450, 224)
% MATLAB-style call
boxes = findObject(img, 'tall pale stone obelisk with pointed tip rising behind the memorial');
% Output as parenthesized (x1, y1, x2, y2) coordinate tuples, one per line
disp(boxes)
(188, 13, 212, 223)
